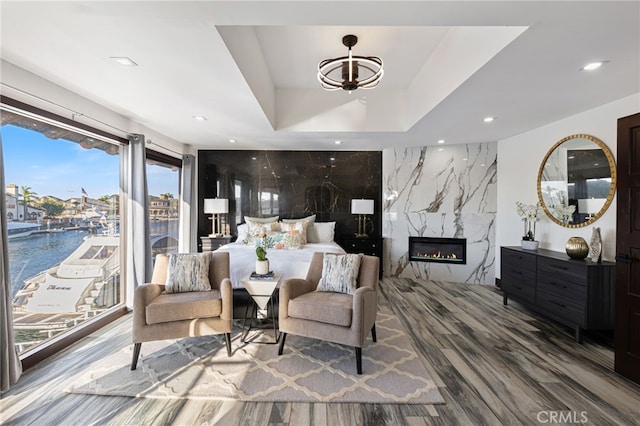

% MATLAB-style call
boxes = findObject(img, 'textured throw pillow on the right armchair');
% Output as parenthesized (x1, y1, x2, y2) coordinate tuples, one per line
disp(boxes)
(316, 253, 362, 294)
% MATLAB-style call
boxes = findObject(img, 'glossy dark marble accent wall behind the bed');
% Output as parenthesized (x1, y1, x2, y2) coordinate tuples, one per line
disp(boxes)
(198, 150, 382, 245)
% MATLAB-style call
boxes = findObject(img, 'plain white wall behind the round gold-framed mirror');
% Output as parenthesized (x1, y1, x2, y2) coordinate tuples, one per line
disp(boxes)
(495, 93, 640, 277)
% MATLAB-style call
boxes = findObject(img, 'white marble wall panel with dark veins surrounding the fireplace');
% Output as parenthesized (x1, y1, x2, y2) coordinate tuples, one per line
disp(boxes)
(382, 142, 497, 284)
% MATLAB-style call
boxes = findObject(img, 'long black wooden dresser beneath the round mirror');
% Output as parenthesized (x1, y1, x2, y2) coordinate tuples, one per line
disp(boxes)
(500, 247, 615, 342)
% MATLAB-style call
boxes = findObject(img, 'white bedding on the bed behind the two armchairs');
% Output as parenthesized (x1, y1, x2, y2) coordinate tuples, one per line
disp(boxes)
(216, 242, 345, 288)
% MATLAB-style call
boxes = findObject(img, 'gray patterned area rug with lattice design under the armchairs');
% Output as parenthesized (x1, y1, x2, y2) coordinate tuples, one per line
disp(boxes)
(67, 312, 444, 404)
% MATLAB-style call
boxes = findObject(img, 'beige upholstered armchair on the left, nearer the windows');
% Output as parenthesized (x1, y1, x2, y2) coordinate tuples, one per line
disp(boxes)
(131, 252, 233, 370)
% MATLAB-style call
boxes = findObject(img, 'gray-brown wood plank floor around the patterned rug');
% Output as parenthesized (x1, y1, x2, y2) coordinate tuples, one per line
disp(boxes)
(0, 278, 640, 425)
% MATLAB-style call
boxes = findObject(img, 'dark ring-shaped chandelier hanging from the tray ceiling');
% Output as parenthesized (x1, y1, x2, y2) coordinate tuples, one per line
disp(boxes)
(318, 34, 384, 93)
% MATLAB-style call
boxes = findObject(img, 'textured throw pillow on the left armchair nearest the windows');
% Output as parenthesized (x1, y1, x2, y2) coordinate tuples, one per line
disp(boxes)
(164, 252, 211, 293)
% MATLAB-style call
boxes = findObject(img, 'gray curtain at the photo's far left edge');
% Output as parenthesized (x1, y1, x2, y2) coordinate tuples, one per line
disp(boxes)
(0, 136, 22, 392)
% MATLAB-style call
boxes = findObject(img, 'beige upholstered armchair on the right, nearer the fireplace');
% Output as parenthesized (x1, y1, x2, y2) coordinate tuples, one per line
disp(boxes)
(278, 253, 380, 374)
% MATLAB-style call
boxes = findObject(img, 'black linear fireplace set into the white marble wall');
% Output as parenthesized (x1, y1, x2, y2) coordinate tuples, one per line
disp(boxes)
(409, 237, 467, 265)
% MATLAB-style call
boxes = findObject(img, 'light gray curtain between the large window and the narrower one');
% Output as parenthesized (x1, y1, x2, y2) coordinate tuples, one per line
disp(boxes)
(120, 134, 152, 307)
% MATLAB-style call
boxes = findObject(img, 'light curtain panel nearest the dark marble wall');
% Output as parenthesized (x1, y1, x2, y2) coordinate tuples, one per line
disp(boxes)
(178, 154, 198, 253)
